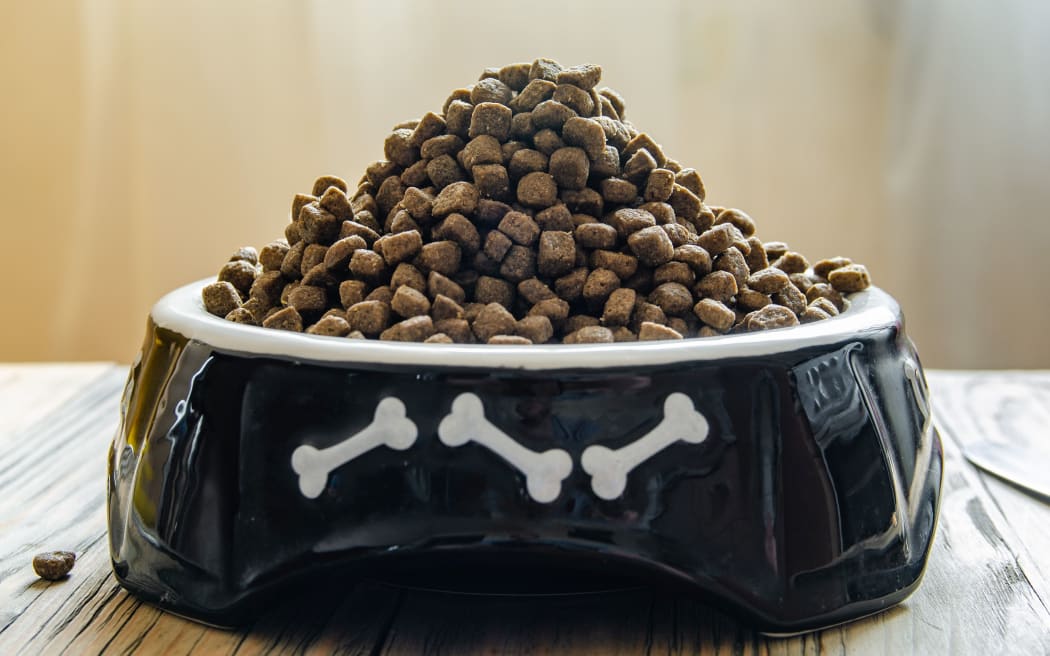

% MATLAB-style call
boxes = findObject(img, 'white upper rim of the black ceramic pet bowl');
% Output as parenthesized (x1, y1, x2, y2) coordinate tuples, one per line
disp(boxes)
(150, 278, 901, 371)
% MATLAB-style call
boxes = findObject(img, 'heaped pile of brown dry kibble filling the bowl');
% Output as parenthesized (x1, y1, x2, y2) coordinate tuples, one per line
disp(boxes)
(204, 59, 869, 344)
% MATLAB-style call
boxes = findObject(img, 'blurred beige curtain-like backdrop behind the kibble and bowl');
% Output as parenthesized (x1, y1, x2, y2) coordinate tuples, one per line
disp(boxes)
(0, 0, 1050, 367)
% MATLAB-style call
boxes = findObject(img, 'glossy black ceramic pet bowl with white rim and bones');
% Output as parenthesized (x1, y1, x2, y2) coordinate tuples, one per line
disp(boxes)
(109, 281, 942, 633)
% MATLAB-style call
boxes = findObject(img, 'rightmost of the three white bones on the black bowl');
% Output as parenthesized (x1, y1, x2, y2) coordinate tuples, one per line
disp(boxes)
(580, 392, 709, 499)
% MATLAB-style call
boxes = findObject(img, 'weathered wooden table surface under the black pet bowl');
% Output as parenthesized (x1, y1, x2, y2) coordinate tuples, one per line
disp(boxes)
(0, 364, 1050, 655)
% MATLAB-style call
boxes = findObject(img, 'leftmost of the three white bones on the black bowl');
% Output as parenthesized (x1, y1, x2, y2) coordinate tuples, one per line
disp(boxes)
(292, 397, 419, 499)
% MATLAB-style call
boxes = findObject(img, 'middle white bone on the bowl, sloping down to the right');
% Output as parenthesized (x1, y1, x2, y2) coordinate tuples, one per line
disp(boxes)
(438, 393, 572, 504)
